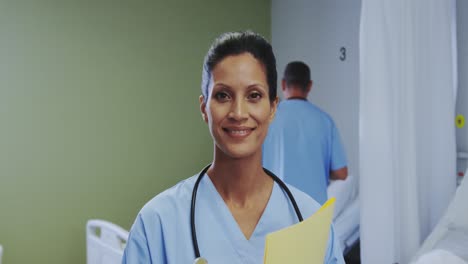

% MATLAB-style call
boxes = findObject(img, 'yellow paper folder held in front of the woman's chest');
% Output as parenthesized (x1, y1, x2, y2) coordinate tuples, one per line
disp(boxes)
(263, 198, 335, 264)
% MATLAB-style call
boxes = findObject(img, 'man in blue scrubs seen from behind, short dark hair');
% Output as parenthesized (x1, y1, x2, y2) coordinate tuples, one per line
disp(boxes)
(263, 62, 348, 204)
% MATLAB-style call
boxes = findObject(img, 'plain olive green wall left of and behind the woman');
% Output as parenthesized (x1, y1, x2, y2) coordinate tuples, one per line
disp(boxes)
(0, 0, 270, 264)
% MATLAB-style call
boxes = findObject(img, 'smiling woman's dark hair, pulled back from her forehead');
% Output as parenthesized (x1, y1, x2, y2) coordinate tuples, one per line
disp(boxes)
(201, 31, 277, 101)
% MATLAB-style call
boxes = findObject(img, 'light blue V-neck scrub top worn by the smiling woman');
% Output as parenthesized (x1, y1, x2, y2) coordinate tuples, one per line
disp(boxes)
(122, 173, 344, 264)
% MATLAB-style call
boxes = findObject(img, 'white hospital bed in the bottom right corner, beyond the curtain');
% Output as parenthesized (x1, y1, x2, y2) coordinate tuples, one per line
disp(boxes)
(412, 173, 468, 264)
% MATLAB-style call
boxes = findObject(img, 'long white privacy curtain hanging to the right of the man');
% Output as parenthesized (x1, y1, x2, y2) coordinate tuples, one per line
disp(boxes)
(359, 0, 456, 264)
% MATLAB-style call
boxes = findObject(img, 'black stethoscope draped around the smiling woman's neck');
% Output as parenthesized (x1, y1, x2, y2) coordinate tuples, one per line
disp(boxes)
(190, 164, 303, 264)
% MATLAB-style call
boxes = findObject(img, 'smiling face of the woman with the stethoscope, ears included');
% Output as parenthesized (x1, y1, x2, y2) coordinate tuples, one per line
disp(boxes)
(200, 53, 277, 158)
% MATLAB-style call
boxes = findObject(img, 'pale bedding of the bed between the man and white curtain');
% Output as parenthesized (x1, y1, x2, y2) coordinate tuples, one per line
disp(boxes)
(327, 175, 360, 254)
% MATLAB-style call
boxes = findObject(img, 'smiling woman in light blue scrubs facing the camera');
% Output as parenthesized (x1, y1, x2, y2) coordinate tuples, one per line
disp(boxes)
(122, 31, 344, 264)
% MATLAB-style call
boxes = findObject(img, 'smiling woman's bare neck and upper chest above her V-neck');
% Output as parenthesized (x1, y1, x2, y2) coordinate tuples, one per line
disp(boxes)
(207, 153, 273, 207)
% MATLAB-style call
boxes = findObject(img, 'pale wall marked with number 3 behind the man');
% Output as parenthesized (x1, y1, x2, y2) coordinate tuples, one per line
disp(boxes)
(271, 0, 361, 175)
